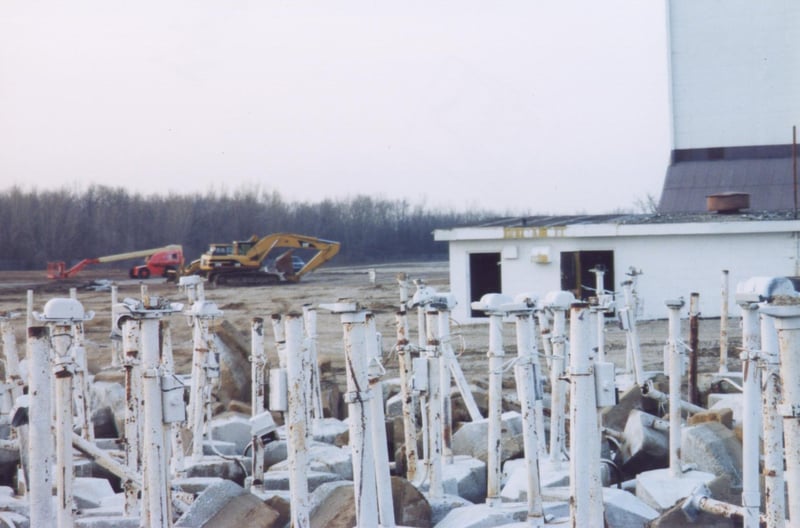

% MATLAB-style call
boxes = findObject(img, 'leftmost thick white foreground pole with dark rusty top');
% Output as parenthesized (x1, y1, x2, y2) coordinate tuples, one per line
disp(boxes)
(27, 326, 55, 526)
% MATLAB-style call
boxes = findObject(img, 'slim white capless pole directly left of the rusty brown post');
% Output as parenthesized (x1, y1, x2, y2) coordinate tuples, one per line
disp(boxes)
(666, 299, 684, 478)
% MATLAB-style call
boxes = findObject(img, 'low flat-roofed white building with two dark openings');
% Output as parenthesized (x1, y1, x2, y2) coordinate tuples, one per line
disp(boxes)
(434, 214, 800, 322)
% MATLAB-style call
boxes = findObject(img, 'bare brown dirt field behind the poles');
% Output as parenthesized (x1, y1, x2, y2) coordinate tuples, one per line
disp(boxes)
(0, 262, 741, 404)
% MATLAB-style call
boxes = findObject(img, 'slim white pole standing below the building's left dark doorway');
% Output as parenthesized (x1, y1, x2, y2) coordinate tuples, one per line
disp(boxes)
(486, 312, 505, 507)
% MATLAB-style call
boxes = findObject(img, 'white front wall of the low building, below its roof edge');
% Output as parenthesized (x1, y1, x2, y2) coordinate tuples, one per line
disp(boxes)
(450, 232, 800, 322)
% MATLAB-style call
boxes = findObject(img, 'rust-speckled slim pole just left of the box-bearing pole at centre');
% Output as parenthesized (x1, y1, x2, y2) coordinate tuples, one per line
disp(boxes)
(395, 310, 418, 482)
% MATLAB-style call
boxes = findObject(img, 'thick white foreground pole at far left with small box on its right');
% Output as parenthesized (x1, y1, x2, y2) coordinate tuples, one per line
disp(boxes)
(139, 317, 172, 527)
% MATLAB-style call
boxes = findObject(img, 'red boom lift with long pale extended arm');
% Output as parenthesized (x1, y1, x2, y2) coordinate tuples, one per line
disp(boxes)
(47, 245, 183, 279)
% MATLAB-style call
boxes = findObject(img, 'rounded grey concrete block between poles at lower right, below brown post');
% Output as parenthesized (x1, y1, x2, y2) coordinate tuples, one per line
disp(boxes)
(681, 422, 742, 488)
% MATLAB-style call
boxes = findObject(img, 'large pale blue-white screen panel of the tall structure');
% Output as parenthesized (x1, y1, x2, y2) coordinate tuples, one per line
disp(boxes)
(667, 0, 800, 149)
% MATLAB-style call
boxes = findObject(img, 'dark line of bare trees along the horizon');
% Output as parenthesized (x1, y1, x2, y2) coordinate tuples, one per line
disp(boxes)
(0, 186, 497, 270)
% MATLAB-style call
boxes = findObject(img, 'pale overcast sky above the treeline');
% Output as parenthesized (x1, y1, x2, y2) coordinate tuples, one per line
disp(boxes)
(0, 0, 671, 214)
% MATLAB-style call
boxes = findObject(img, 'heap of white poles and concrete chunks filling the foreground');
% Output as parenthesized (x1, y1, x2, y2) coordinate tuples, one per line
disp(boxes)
(0, 270, 800, 528)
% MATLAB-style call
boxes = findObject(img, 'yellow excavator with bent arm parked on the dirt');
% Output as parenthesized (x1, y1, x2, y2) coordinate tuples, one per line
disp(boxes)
(181, 233, 340, 286)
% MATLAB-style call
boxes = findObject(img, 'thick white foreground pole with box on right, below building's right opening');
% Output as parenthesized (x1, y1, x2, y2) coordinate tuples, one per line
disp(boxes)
(569, 302, 604, 526)
